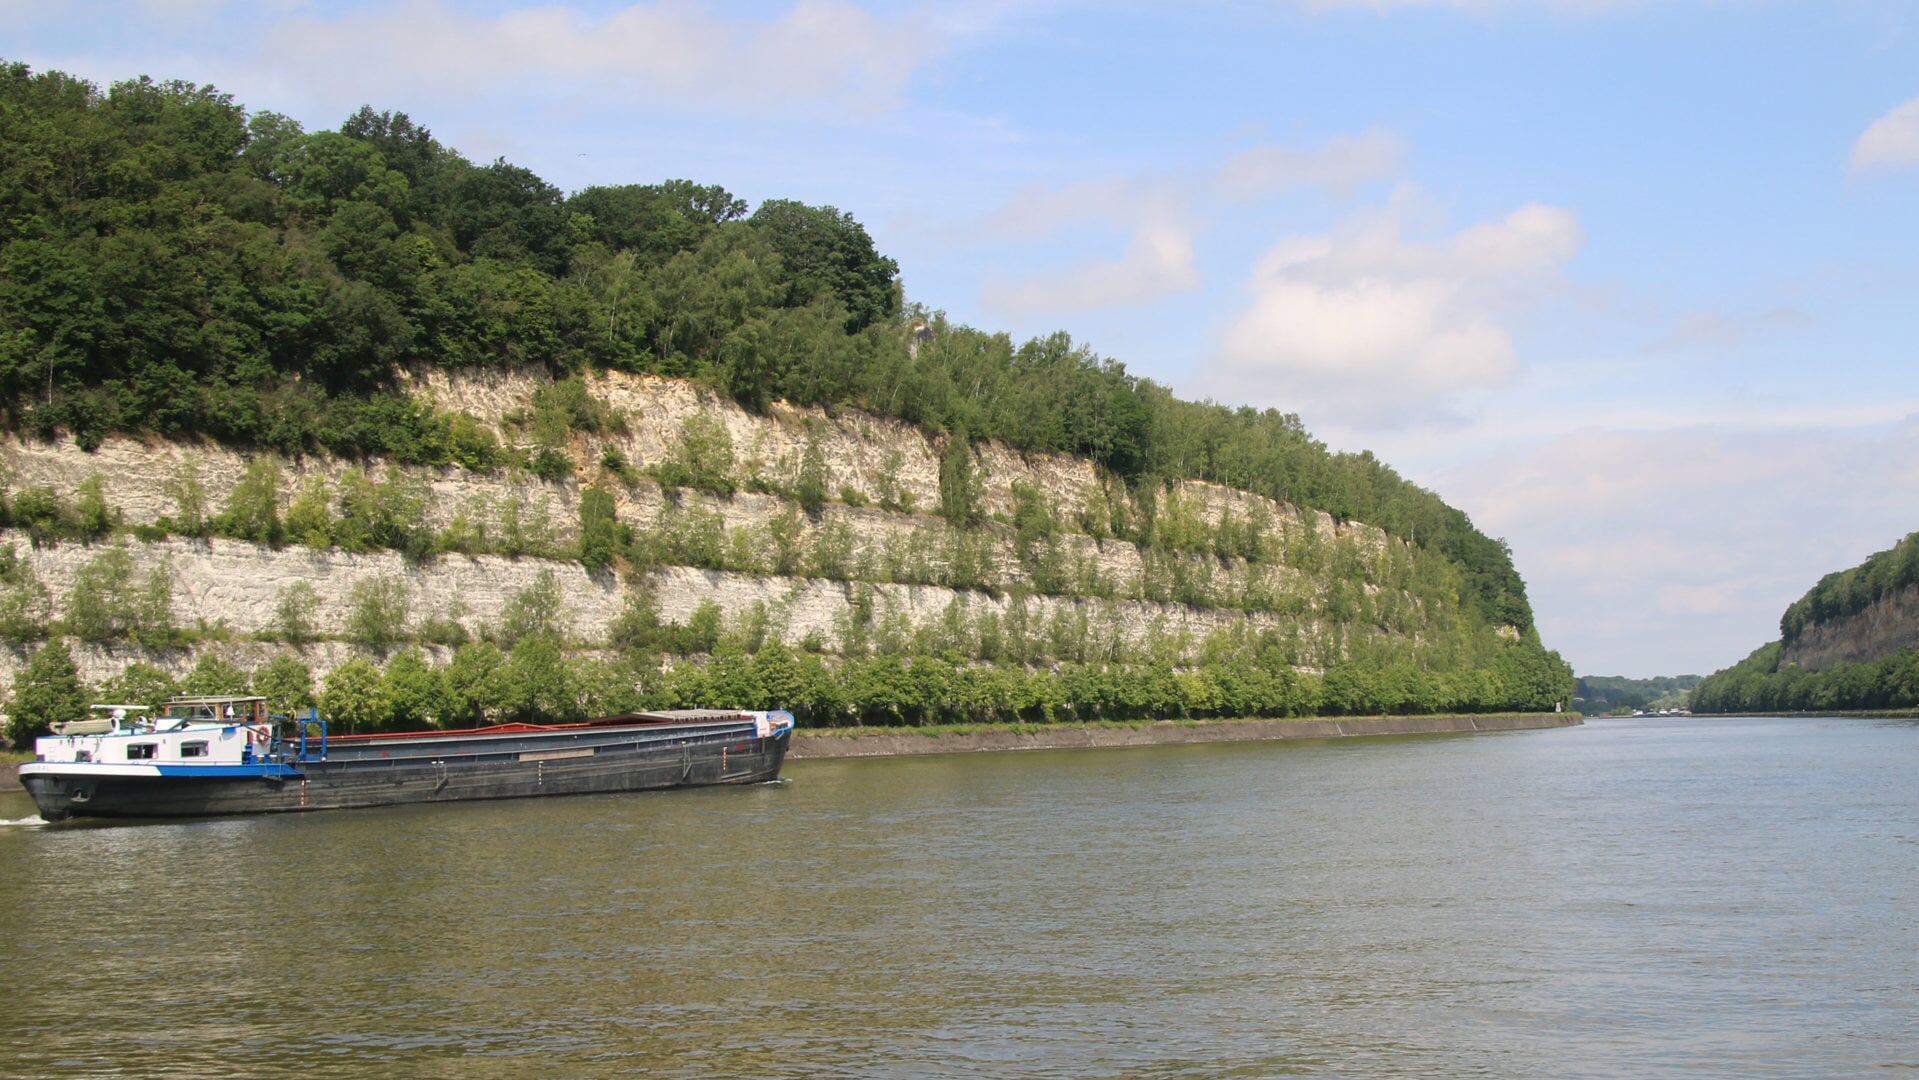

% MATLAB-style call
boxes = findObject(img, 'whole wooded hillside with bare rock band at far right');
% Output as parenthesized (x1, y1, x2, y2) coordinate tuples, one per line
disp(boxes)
(1693, 533, 1919, 712)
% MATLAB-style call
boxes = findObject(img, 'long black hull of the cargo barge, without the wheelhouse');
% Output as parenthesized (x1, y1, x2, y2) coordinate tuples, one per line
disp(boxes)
(21, 729, 791, 821)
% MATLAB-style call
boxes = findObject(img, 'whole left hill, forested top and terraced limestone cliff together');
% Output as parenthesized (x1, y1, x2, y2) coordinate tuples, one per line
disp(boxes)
(0, 65, 1572, 733)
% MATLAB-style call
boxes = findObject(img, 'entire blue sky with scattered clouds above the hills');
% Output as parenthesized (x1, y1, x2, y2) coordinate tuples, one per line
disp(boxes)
(0, 0, 1919, 677)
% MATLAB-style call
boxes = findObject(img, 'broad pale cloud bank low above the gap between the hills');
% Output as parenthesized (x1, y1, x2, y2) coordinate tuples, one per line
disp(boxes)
(1424, 414, 1919, 675)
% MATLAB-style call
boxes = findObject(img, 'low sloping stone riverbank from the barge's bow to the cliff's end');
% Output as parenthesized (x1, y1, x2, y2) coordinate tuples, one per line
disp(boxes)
(787, 712, 1583, 762)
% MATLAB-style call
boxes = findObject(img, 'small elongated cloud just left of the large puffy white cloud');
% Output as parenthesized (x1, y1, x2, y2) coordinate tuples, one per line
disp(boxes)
(981, 224, 1199, 315)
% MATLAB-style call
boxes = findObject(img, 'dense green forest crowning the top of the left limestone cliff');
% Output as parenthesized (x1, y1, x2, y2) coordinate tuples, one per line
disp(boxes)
(0, 63, 1531, 631)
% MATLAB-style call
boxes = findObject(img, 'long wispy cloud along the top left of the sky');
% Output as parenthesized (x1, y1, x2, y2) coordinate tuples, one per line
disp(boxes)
(261, 0, 940, 113)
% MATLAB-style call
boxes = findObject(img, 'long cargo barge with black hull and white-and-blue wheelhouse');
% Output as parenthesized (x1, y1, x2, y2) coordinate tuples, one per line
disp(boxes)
(19, 696, 793, 821)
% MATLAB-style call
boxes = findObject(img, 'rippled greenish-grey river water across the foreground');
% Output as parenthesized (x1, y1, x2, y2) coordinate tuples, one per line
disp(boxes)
(0, 719, 1919, 1078)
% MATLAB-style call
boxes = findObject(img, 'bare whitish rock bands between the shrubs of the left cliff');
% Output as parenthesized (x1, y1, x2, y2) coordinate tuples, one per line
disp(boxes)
(0, 372, 1399, 685)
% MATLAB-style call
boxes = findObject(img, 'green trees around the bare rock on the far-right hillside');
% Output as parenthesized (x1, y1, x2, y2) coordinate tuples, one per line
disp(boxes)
(1693, 533, 1919, 714)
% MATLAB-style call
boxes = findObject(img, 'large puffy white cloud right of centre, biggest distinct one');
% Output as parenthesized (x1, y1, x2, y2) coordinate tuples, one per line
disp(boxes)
(1207, 188, 1581, 414)
